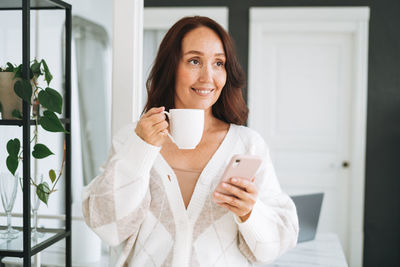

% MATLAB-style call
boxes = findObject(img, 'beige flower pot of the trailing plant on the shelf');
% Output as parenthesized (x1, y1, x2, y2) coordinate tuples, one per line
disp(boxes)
(0, 72, 22, 120)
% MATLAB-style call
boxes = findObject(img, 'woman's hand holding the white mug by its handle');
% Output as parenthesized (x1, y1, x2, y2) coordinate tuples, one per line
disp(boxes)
(135, 107, 168, 146)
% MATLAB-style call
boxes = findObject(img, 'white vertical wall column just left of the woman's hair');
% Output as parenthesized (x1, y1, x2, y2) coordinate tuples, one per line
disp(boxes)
(111, 0, 143, 136)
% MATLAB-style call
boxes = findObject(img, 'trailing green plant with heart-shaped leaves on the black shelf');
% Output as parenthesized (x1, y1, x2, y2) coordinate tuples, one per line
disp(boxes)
(0, 59, 66, 205)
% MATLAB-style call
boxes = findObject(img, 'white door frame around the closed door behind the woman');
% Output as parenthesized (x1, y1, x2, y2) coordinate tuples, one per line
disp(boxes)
(248, 7, 369, 266)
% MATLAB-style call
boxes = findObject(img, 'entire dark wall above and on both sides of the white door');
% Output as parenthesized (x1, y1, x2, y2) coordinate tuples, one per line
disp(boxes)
(144, 0, 400, 267)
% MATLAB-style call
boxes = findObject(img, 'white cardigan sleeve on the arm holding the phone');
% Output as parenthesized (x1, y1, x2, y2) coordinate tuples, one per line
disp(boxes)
(234, 136, 299, 264)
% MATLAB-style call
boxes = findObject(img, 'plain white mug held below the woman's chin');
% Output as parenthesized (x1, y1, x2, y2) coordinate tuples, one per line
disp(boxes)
(164, 109, 204, 149)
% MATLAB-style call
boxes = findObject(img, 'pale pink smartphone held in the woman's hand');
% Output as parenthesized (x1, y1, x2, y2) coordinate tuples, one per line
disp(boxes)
(218, 155, 262, 197)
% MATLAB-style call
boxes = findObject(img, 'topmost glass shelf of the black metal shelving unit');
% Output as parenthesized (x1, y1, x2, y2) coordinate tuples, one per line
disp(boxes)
(0, 0, 71, 10)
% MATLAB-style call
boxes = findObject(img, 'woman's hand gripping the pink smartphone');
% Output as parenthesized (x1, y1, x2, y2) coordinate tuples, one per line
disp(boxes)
(213, 177, 258, 222)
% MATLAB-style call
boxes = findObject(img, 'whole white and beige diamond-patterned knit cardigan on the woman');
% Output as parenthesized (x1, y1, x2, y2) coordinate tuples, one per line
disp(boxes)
(82, 124, 298, 267)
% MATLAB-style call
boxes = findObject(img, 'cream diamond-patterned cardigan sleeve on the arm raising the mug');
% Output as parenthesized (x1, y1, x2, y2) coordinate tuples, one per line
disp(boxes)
(82, 124, 160, 246)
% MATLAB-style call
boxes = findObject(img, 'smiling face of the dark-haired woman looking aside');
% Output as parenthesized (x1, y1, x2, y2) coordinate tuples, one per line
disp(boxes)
(175, 27, 226, 110)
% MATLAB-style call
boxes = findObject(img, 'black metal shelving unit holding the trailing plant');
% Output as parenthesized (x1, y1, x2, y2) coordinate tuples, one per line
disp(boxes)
(0, 0, 72, 267)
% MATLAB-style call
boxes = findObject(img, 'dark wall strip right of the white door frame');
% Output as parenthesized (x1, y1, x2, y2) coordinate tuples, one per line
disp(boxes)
(364, 0, 400, 267)
